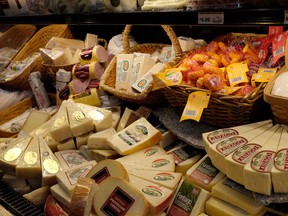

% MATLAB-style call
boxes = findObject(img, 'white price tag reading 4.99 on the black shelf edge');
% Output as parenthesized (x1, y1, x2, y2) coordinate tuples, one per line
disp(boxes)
(198, 12, 224, 25)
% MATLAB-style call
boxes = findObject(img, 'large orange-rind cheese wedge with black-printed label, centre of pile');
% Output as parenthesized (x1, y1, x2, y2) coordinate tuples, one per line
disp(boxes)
(107, 117, 162, 155)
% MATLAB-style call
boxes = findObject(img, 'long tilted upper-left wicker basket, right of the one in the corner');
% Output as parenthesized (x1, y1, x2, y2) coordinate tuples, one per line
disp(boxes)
(0, 25, 73, 90)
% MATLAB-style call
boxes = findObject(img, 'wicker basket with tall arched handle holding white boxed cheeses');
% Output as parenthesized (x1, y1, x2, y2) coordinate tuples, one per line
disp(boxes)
(100, 25, 182, 105)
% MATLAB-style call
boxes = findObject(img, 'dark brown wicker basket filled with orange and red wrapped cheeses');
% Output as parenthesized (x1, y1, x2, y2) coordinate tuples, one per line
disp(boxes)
(162, 34, 271, 127)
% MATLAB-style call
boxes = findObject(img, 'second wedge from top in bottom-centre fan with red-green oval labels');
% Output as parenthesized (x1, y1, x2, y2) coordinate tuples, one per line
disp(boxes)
(120, 155, 175, 172)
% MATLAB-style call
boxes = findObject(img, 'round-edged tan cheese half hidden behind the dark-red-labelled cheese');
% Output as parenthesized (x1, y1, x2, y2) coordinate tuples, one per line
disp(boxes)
(86, 159, 129, 184)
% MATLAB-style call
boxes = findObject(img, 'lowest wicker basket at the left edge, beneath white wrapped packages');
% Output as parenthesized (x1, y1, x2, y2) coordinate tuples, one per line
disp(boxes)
(0, 98, 36, 137)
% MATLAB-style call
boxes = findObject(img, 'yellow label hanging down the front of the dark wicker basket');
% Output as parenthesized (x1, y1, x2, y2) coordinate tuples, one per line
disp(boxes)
(180, 91, 211, 122)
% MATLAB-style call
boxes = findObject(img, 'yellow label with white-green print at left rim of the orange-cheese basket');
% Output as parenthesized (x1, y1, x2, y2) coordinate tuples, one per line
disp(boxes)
(152, 68, 182, 91)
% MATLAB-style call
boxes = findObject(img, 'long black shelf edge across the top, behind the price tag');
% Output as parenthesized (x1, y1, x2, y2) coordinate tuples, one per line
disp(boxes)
(0, 8, 288, 26)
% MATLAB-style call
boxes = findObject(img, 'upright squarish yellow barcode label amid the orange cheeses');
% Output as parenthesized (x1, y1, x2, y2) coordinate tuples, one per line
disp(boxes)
(226, 62, 249, 87)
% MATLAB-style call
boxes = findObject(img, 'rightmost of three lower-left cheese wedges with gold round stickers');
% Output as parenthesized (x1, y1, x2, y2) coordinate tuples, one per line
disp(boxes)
(39, 137, 63, 186)
